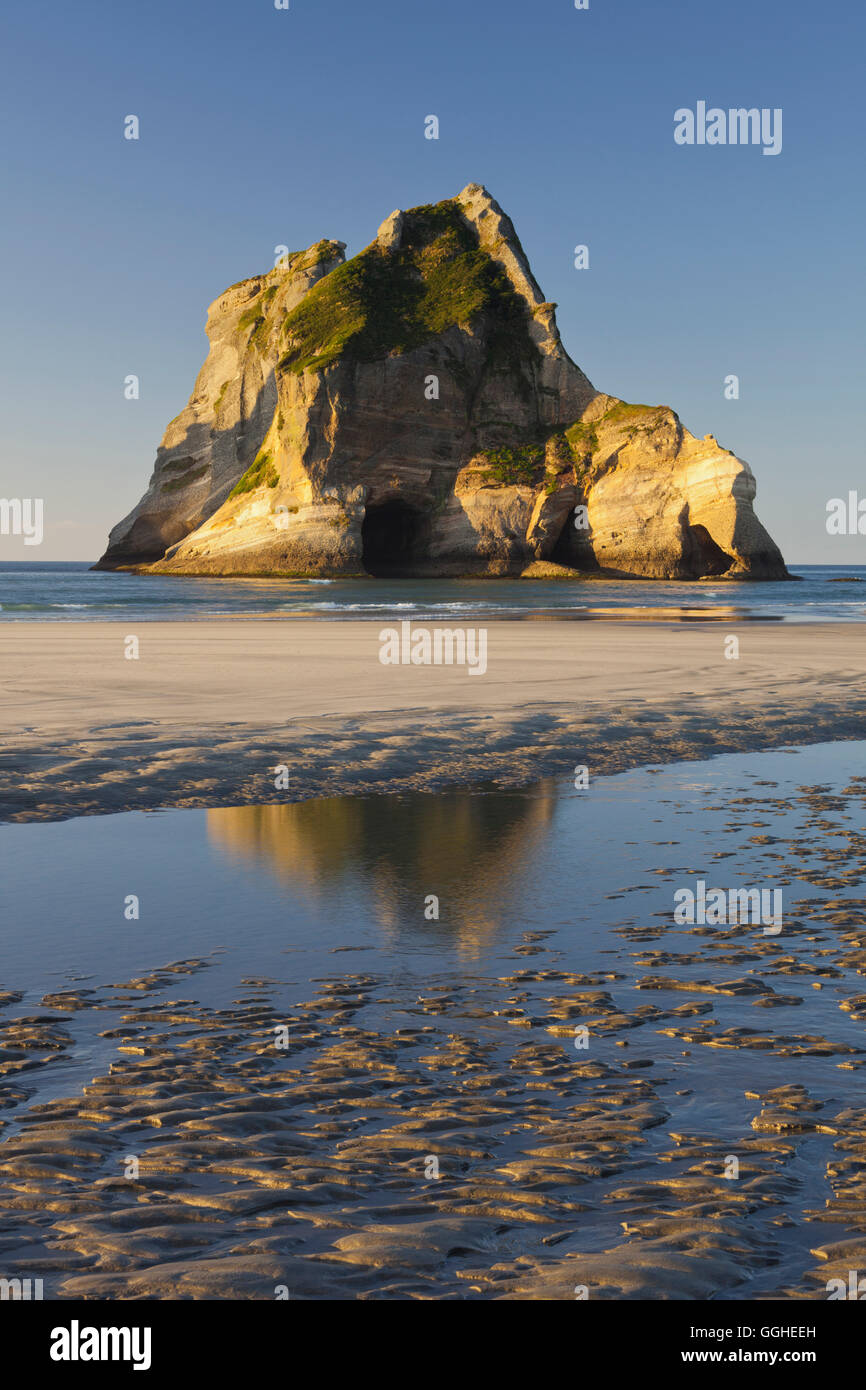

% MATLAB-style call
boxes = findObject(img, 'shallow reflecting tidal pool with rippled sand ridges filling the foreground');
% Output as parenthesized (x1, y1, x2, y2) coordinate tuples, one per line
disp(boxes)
(0, 742, 866, 1298)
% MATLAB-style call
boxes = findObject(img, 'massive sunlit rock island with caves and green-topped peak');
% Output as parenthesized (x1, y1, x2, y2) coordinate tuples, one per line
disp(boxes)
(100, 183, 787, 578)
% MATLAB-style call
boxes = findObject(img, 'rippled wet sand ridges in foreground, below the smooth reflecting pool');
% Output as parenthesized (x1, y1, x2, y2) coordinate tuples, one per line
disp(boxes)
(0, 776, 866, 1300)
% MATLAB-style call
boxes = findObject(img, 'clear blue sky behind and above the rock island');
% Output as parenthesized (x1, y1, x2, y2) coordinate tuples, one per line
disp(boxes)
(0, 0, 866, 563)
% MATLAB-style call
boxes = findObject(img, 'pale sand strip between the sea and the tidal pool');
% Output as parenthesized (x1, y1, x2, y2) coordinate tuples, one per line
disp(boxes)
(0, 619, 866, 820)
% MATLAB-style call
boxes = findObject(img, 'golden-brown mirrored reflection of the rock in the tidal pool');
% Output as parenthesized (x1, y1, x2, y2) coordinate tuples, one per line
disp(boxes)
(207, 792, 553, 951)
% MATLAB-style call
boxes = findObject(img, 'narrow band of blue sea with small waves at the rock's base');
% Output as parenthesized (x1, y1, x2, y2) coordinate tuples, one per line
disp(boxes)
(0, 562, 866, 623)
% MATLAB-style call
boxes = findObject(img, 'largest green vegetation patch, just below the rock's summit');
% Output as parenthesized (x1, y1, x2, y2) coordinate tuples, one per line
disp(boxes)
(279, 200, 535, 374)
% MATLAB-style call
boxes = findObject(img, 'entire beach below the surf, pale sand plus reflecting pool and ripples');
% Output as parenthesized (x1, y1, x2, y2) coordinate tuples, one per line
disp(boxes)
(0, 619, 866, 1301)
